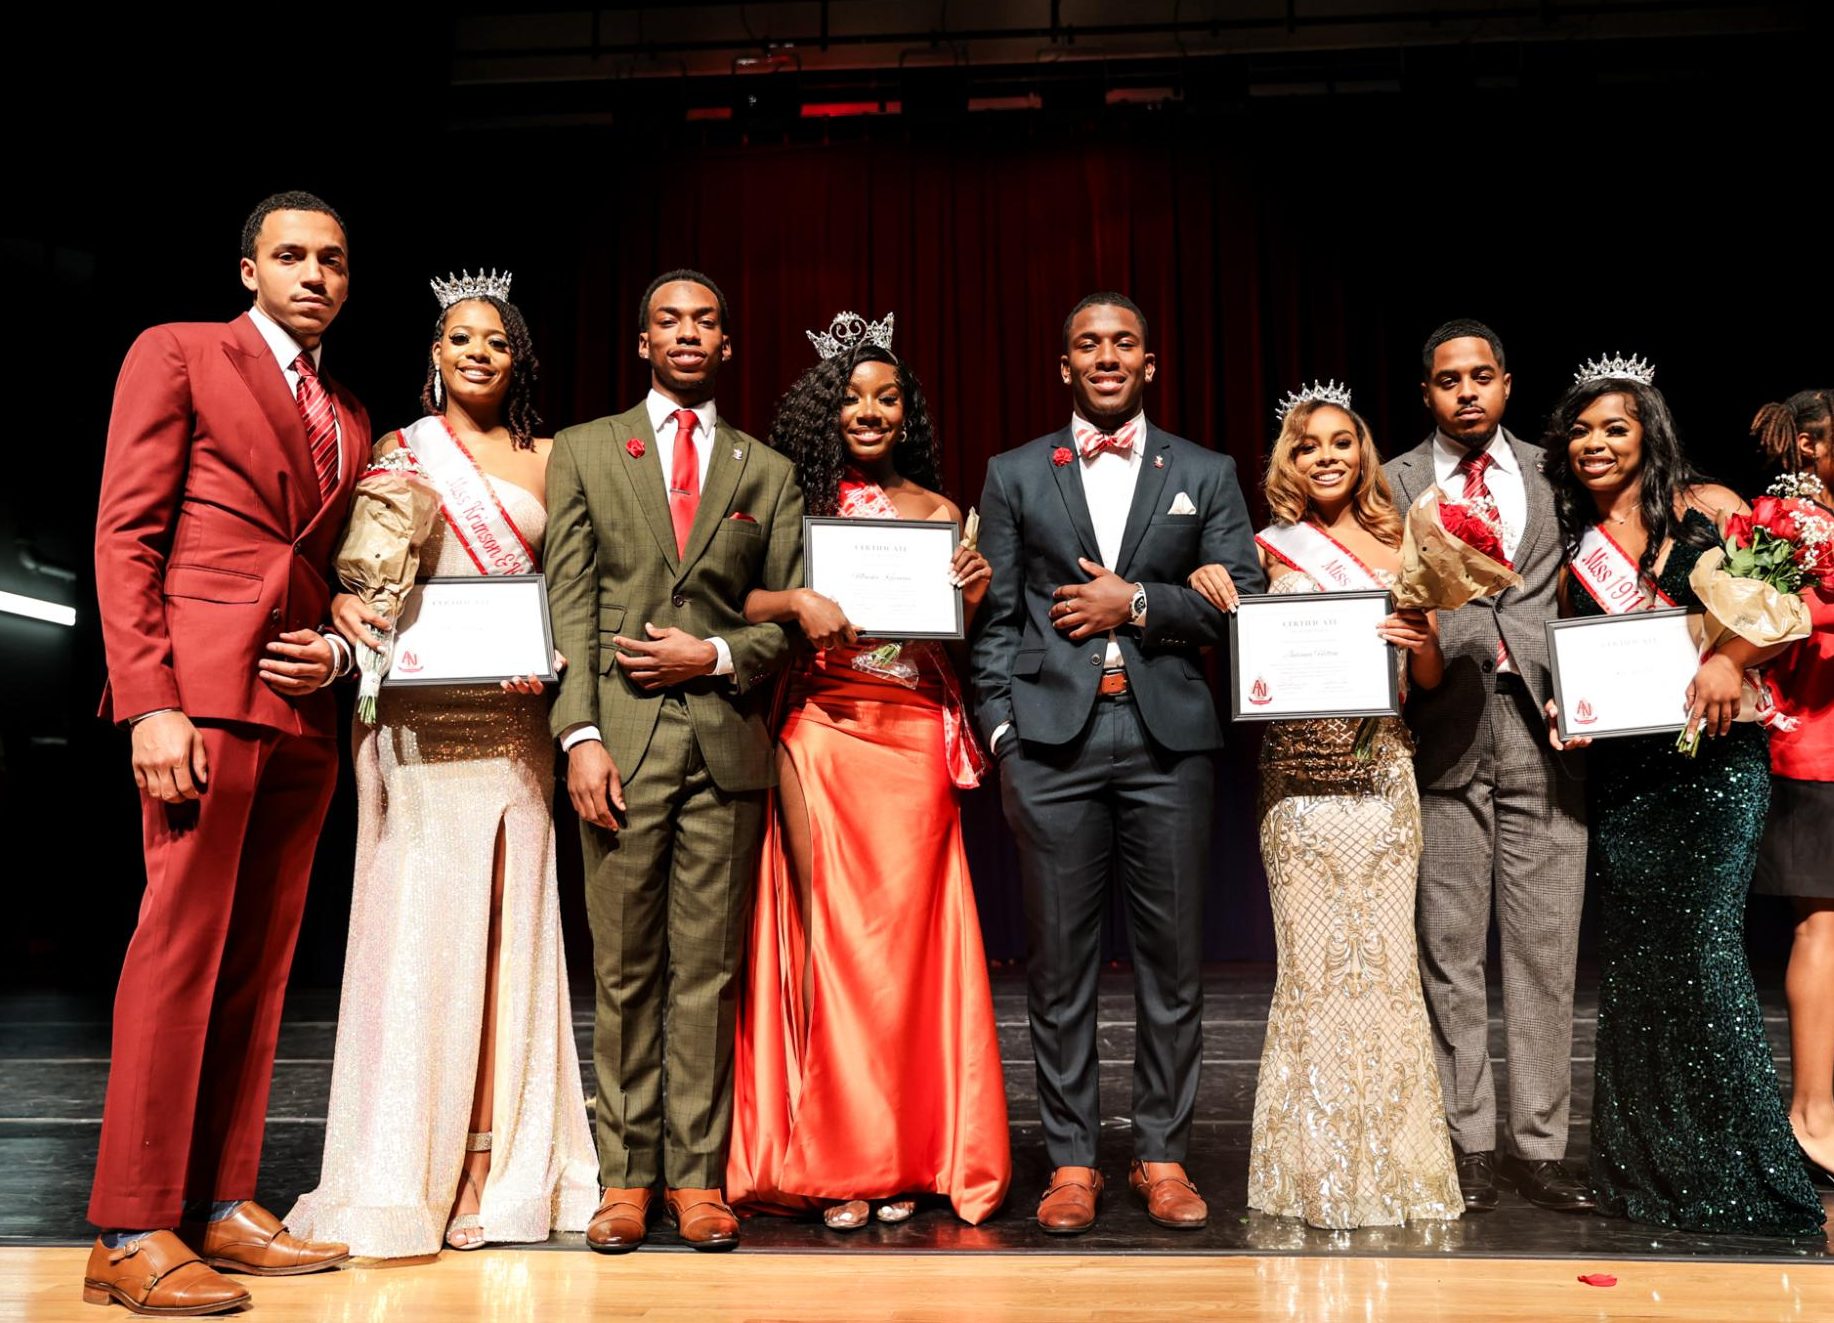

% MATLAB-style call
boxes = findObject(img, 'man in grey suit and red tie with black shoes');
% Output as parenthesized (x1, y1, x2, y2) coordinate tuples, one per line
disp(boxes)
(1387, 321, 1592, 1213)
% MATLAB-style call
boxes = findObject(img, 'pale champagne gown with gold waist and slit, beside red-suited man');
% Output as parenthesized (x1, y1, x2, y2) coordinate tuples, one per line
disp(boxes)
(286, 479, 598, 1259)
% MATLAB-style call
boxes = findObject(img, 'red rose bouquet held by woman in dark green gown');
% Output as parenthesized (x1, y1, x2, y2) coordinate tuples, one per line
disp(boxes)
(1674, 473, 1834, 758)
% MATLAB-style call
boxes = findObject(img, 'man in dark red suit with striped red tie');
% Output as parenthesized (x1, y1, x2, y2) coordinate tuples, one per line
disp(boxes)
(83, 193, 370, 1314)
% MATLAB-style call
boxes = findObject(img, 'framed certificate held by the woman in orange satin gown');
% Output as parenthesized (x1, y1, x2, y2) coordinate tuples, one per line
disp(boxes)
(803, 516, 965, 639)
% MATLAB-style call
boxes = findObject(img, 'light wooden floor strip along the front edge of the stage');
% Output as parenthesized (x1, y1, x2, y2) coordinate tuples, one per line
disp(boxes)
(0, 1248, 1834, 1323)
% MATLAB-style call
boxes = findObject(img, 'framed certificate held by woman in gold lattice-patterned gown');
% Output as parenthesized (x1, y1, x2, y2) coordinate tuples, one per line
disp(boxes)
(1229, 591, 1401, 721)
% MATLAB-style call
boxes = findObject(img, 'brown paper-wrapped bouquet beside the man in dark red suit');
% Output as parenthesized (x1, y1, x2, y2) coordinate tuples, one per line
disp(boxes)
(336, 448, 440, 725)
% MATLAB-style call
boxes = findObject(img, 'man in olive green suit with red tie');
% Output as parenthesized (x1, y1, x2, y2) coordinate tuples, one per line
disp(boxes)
(547, 272, 803, 1251)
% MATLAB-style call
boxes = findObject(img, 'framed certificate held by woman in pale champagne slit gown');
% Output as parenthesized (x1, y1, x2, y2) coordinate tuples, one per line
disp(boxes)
(381, 574, 558, 688)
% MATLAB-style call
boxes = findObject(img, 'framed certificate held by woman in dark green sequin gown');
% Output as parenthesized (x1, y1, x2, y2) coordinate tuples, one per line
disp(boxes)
(1548, 607, 1700, 739)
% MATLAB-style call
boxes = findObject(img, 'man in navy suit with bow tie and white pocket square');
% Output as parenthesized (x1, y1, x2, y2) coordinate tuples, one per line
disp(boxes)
(974, 292, 1264, 1233)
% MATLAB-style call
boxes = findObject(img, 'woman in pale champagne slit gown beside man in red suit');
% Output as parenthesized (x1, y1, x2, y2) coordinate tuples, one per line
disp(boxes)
(286, 286, 598, 1259)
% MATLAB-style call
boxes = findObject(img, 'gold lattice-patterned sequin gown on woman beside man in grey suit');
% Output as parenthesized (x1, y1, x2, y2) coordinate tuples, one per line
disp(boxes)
(1249, 573, 1464, 1228)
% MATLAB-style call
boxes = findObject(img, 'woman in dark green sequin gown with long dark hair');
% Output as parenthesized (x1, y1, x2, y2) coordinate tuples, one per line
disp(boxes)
(1544, 366, 1823, 1235)
